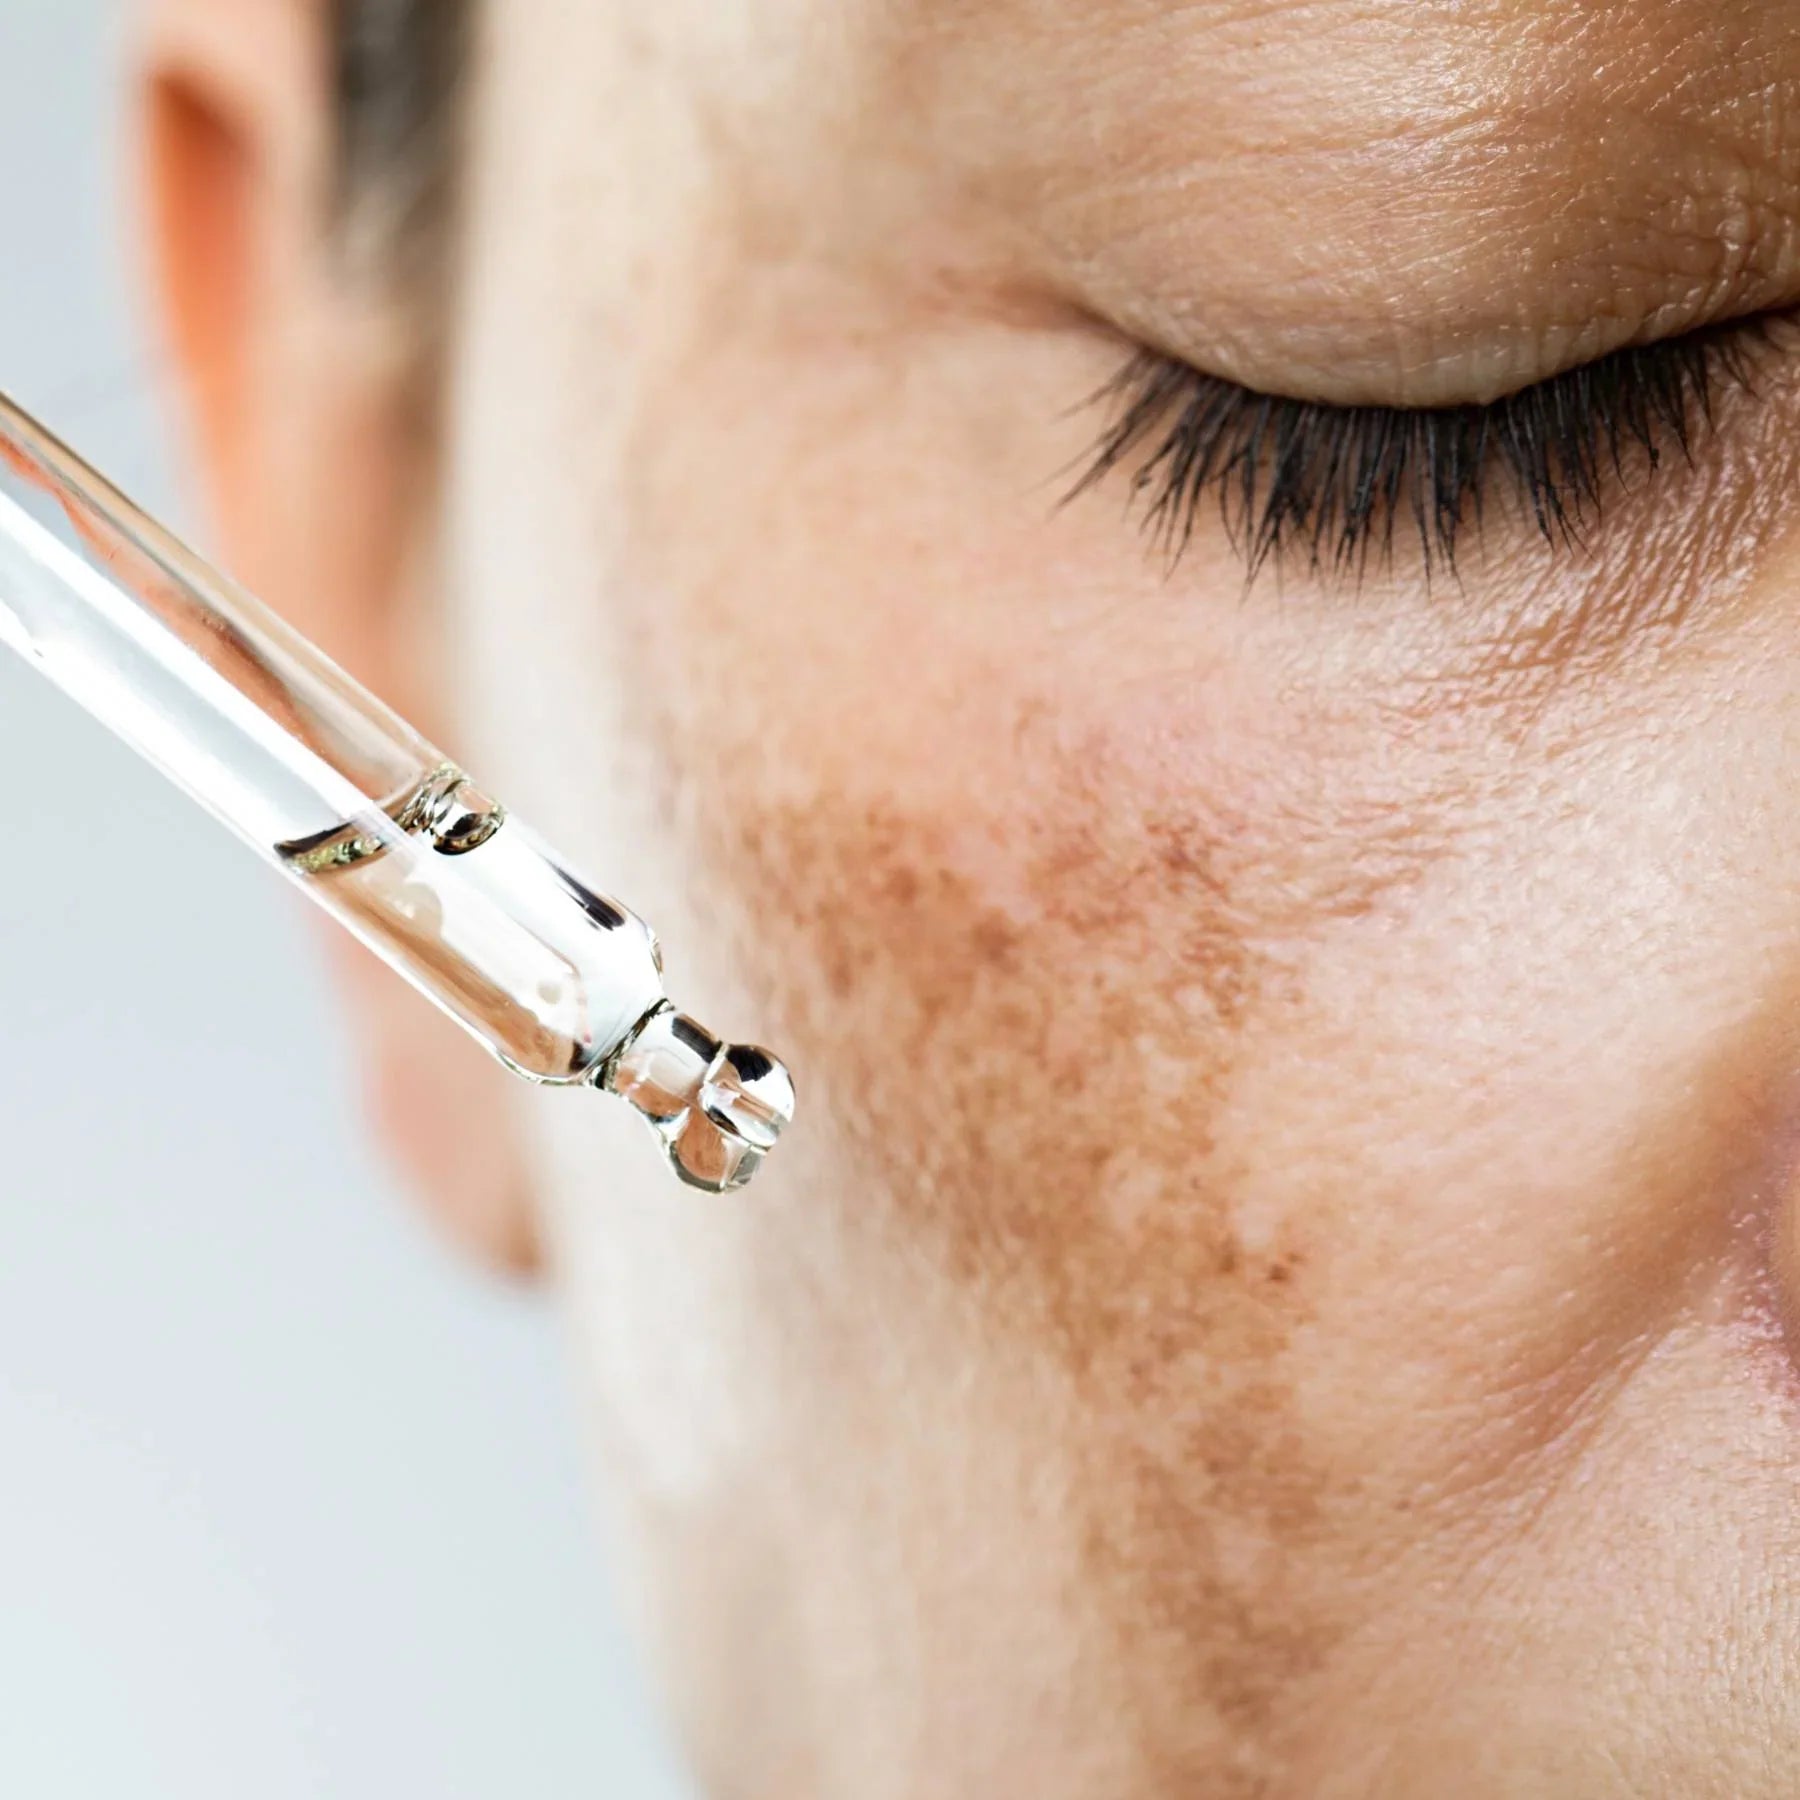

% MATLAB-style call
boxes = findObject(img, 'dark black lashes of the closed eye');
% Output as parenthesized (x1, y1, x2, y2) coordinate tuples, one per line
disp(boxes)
(1067, 319, 1768, 576)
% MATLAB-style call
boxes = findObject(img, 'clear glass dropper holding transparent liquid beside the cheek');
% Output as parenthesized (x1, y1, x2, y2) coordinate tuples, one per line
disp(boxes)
(0, 394, 794, 1193)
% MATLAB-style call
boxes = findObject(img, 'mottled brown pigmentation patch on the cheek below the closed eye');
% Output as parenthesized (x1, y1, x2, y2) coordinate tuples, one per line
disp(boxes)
(702, 709, 1461, 1795)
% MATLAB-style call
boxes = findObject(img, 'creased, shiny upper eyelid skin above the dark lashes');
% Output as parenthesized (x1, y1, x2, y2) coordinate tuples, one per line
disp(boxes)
(878, 0, 1800, 405)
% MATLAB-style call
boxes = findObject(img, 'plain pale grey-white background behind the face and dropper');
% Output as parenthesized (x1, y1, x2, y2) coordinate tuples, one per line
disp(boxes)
(0, 0, 679, 1800)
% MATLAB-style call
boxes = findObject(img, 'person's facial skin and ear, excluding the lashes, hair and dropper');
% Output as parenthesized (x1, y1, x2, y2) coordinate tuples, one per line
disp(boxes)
(146, 0, 1800, 1800)
